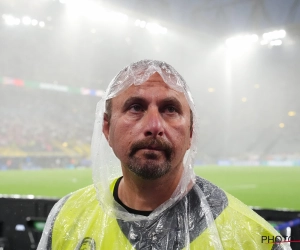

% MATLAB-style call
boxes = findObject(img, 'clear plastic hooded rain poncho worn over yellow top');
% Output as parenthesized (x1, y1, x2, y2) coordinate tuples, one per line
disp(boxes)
(38, 60, 289, 250)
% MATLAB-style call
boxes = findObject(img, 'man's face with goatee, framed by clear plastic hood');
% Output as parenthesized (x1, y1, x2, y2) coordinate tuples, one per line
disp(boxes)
(103, 73, 192, 179)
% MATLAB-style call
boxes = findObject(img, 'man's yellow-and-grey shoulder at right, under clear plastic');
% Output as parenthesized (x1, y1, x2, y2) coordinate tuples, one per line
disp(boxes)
(193, 177, 290, 249)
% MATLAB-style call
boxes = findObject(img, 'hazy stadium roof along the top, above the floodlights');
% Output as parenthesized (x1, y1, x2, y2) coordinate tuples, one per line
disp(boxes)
(0, 0, 300, 37)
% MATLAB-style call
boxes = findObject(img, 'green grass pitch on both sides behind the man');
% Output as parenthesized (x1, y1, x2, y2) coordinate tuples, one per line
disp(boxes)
(0, 166, 300, 210)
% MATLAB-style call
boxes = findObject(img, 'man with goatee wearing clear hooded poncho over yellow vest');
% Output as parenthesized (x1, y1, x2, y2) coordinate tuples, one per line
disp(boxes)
(38, 60, 290, 250)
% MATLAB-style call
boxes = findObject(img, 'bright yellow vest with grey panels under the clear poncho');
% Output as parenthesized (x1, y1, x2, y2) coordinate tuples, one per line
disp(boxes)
(49, 178, 285, 250)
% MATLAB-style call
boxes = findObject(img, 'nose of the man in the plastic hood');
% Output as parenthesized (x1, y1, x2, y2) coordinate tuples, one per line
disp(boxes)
(144, 108, 164, 137)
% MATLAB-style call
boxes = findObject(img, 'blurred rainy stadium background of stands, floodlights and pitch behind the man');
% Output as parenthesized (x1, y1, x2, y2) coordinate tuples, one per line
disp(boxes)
(0, 0, 300, 250)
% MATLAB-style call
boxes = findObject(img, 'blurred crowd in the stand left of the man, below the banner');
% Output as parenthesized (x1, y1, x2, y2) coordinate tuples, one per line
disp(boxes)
(0, 85, 97, 168)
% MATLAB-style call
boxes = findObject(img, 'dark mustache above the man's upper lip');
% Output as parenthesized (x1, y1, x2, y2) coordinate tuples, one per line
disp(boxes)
(129, 138, 173, 159)
